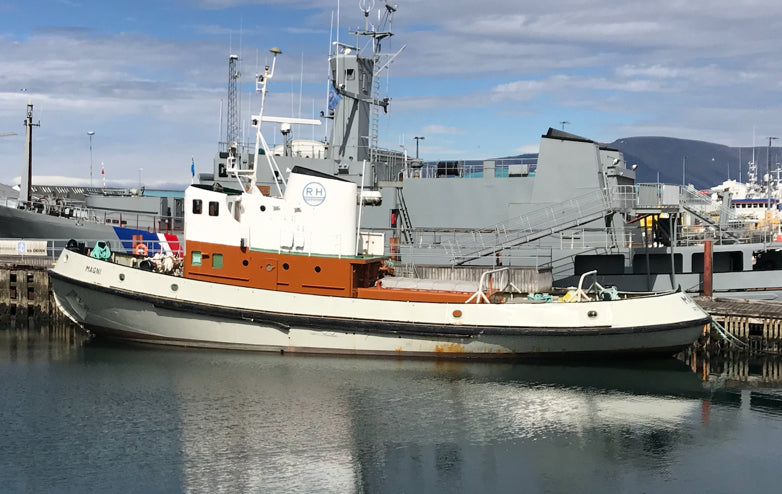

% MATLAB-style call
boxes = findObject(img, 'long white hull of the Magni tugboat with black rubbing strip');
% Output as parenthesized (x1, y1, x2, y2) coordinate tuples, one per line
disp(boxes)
(51, 251, 709, 358)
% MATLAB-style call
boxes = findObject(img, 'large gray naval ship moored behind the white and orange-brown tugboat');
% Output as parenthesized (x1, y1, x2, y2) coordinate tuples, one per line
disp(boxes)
(199, 5, 782, 299)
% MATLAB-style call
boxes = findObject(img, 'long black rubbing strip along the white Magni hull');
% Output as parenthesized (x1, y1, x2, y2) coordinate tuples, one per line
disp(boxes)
(49, 271, 711, 338)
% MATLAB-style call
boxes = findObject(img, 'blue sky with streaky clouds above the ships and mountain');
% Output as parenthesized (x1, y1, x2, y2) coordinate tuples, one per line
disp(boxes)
(0, 0, 782, 188)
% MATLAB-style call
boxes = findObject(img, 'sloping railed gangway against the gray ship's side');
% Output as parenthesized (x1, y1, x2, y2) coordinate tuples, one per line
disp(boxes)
(451, 190, 632, 265)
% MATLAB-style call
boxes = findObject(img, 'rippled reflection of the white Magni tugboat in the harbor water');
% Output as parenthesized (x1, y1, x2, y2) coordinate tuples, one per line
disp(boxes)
(75, 343, 728, 492)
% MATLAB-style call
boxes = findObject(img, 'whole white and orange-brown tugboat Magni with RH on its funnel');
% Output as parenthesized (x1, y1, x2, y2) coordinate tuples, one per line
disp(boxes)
(50, 50, 710, 358)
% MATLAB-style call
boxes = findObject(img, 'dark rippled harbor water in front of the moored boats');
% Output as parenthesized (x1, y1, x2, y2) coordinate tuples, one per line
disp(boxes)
(0, 328, 782, 493)
